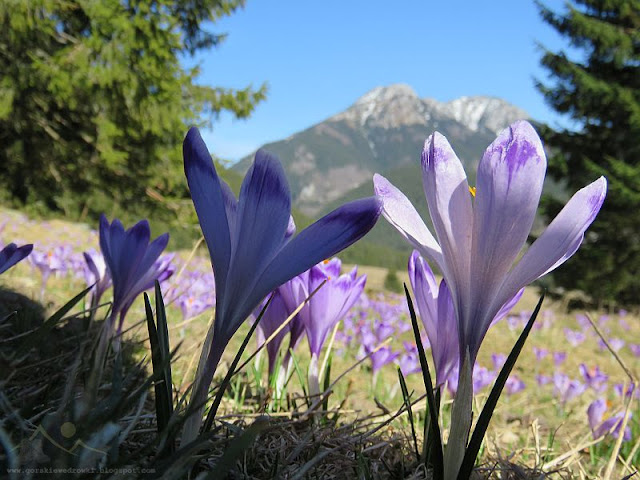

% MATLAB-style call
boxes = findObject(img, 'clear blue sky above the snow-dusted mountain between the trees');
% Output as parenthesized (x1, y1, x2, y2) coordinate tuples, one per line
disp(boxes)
(196, 0, 565, 160)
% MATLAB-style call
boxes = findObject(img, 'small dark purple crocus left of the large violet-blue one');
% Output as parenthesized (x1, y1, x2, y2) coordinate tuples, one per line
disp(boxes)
(100, 215, 174, 340)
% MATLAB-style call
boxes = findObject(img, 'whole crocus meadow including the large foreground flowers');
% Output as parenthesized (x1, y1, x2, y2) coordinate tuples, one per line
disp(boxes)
(0, 122, 640, 479)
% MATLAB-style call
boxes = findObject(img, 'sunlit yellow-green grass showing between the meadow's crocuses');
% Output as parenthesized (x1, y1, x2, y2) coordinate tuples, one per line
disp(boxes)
(0, 205, 640, 475)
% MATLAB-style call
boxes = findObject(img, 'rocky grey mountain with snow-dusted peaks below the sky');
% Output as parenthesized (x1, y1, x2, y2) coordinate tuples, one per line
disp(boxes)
(233, 84, 528, 215)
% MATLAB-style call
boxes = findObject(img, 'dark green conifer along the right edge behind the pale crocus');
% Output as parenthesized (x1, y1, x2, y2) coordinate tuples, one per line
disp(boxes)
(537, 0, 640, 305)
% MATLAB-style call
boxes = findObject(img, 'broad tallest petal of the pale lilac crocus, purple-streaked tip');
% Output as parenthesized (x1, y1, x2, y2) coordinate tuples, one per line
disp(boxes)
(470, 121, 547, 316)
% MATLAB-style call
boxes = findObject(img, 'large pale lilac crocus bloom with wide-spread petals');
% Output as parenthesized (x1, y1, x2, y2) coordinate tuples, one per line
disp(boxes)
(374, 121, 607, 376)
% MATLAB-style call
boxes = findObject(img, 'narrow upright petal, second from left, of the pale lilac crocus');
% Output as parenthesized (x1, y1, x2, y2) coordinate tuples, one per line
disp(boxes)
(422, 132, 473, 328)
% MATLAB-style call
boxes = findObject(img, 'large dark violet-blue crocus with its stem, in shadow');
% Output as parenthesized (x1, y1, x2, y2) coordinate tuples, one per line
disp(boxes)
(182, 128, 382, 444)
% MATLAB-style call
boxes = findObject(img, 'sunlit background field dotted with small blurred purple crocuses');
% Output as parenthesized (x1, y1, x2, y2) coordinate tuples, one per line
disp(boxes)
(1, 206, 640, 475)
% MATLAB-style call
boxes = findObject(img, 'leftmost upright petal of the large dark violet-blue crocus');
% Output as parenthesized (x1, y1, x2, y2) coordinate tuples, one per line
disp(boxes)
(182, 128, 231, 308)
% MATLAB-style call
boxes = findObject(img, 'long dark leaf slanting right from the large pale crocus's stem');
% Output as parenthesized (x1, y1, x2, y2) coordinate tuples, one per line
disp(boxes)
(458, 292, 546, 480)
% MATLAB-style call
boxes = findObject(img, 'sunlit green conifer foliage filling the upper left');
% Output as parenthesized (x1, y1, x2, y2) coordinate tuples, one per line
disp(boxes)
(0, 0, 266, 227)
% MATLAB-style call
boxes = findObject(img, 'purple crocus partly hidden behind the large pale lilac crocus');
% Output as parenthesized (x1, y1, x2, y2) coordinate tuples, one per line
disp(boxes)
(409, 250, 524, 387)
